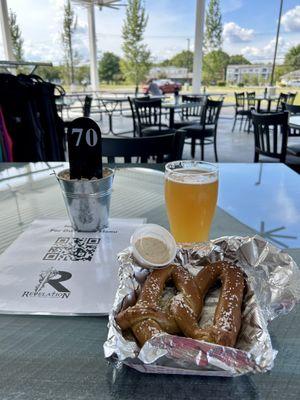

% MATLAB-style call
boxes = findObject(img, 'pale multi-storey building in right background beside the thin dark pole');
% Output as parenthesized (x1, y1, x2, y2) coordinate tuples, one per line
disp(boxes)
(226, 64, 272, 85)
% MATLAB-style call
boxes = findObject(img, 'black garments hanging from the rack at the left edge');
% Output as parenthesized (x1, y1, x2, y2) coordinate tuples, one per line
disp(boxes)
(0, 74, 64, 162)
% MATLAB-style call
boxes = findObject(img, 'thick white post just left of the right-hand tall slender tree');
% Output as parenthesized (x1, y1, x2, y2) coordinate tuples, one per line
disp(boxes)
(193, 0, 205, 93)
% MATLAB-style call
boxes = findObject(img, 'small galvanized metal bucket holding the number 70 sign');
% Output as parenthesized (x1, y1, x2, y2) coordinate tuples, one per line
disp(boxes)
(56, 168, 114, 232)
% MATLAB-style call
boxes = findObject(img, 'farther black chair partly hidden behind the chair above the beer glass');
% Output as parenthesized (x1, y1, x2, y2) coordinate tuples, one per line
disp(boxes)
(174, 95, 206, 129)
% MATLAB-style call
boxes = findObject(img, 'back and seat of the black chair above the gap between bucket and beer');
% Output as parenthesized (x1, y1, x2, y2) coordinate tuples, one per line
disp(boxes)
(132, 98, 174, 136)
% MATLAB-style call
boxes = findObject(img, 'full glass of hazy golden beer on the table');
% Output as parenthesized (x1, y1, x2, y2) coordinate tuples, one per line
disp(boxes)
(165, 161, 218, 243)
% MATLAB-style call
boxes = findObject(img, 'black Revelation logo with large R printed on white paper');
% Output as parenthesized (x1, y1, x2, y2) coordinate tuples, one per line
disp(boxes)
(22, 268, 72, 299)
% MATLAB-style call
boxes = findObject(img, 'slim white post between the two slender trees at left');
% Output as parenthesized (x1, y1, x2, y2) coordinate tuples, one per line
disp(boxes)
(88, 2, 99, 91)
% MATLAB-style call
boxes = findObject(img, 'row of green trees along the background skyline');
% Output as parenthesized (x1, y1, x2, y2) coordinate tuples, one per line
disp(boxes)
(9, 0, 300, 90)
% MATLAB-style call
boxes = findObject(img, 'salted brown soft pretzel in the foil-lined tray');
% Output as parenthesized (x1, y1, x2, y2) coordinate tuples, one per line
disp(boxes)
(116, 262, 244, 347)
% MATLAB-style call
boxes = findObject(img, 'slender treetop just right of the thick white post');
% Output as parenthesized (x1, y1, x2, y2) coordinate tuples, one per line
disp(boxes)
(204, 0, 223, 52)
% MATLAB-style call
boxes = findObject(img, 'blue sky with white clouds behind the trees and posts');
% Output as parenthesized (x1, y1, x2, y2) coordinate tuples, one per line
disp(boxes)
(0, 0, 300, 64)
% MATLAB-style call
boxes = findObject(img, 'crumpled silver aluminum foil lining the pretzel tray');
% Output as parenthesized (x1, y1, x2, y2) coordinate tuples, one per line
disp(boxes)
(104, 236, 300, 377)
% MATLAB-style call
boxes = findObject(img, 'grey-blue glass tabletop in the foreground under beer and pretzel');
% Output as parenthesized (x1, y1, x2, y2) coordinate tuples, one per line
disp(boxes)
(0, 163, 300, 400)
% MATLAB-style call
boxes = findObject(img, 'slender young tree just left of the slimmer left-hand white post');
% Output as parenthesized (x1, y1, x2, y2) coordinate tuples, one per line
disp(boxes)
(61, 0, 77, 83)
